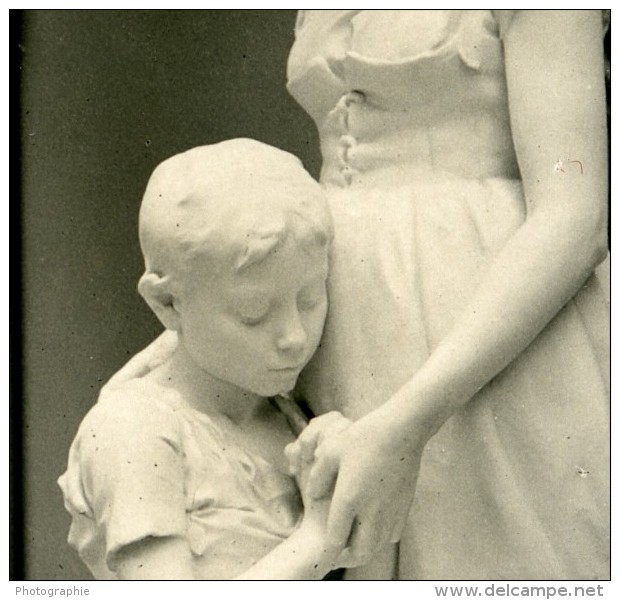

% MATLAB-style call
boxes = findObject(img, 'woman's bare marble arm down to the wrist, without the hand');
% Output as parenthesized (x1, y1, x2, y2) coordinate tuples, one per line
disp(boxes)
(386, 10, 607, 432)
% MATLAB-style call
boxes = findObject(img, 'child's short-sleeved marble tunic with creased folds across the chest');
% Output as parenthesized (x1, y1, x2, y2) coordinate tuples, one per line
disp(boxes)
(59, 380, 302, 579)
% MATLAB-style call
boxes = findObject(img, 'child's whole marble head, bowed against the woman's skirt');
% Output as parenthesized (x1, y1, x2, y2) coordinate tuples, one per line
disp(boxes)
(138, 139, 332, 396)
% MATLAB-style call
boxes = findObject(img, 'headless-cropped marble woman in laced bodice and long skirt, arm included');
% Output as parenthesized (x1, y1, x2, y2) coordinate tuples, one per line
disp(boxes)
(288, 10, 610, 579)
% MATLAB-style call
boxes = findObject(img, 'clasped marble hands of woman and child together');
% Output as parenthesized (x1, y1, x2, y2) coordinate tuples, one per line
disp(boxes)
(286, 412, 423, 567)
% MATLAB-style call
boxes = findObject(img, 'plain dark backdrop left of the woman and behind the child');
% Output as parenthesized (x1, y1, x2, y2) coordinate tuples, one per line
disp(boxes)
(10, 10, 319, 580)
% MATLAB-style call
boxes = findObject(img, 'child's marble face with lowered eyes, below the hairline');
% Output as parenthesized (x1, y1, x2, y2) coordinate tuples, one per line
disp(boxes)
(179, 238, 328, 396)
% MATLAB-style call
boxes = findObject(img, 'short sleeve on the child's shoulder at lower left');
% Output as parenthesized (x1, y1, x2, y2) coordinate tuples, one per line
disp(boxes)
(61, 388, 186, 571)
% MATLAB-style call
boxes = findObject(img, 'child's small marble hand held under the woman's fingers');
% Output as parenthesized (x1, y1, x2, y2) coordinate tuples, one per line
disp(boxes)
(284, 411, 352, 480)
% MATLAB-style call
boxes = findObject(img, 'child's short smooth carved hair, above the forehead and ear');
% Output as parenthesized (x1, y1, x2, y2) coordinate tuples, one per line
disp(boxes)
(140, 139, 333, 292)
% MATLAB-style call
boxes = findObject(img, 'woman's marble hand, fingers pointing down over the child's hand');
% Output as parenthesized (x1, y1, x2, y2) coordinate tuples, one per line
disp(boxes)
(296, 409, 428, 564)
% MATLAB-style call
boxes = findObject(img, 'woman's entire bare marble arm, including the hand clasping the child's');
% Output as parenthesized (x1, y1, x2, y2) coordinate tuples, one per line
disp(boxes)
(302, 11, 607, 553)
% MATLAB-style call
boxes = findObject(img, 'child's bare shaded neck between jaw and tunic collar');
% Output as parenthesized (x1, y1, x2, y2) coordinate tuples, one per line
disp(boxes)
(158, 344, 268, 424)
